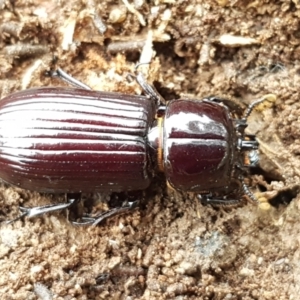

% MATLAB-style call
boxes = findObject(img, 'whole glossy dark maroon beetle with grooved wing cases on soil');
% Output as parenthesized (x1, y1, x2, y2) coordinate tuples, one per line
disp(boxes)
(0, 69, 264, 225)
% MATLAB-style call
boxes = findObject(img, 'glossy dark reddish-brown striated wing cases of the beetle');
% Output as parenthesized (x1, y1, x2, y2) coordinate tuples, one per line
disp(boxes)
(0, 88, 155, 193)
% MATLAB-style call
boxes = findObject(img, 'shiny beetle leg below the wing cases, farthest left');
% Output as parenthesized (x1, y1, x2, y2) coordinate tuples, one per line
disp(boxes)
(6, 199, 78, 224)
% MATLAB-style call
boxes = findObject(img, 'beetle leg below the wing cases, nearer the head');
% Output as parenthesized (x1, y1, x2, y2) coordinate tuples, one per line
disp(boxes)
(71, 200, 140, 226)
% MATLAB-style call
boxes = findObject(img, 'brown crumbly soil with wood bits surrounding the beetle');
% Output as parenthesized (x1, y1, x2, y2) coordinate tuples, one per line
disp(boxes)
(0, 0, 300, 300)
